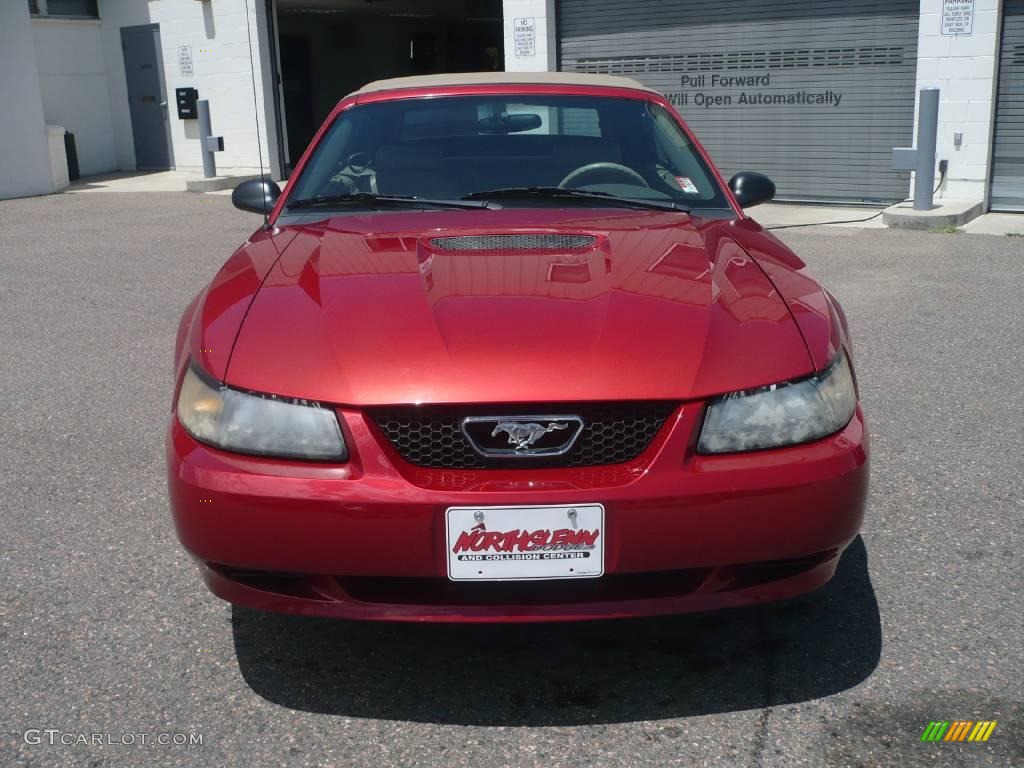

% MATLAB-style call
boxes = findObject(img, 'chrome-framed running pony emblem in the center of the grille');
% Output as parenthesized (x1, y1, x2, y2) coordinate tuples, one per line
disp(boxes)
(462, 416, 583, 458)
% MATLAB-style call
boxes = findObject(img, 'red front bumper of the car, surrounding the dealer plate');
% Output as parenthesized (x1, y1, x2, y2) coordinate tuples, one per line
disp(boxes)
(167, 403, 868, 622)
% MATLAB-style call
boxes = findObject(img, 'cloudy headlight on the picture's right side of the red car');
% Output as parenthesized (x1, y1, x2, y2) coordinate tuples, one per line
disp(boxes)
(697, 352, 857, 454)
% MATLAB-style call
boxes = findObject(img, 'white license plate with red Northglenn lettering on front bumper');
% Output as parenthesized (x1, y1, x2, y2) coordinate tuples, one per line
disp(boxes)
(445, 504, 604, 582)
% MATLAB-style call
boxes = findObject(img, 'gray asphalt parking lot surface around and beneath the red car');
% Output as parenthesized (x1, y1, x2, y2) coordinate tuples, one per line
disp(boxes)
(0, 193, 1024, 768)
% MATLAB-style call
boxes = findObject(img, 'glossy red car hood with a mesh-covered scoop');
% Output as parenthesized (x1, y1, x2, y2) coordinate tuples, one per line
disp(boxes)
(225, 208, 812, 406)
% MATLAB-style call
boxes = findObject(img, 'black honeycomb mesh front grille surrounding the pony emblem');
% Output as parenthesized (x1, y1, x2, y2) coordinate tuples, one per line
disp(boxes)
(370, 402, 675, 469)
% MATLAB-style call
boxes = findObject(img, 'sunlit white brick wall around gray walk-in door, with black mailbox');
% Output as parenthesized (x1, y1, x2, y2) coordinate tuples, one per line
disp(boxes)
(99, 0, 278, 174)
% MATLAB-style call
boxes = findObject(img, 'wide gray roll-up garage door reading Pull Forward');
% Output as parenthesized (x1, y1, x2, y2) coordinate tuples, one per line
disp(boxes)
(558, 0, 919, 201)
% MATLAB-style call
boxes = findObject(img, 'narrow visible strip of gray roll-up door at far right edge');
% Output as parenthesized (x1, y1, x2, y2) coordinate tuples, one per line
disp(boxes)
(991, 0, 1024, 211)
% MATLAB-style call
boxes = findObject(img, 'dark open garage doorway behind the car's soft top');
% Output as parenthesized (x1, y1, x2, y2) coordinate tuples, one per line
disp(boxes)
(276, 0, 505, 172)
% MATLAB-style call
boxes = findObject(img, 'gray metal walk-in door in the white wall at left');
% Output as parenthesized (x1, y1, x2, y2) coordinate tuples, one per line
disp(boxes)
(121, 24, 171, 170)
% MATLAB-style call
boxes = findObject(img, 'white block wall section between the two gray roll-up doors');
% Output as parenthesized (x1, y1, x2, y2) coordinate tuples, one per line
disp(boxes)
(911, 0, 1001, 200)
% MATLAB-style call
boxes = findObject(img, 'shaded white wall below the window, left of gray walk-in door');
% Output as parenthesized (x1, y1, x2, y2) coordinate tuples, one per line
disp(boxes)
(32, 18, 118, 174)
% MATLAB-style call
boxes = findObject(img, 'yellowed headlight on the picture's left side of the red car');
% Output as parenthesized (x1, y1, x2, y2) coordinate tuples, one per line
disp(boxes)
(178, 367, 348, 461)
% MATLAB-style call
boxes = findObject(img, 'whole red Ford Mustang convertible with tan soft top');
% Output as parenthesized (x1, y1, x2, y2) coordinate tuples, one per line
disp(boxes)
(167, 73, 868, 622)
